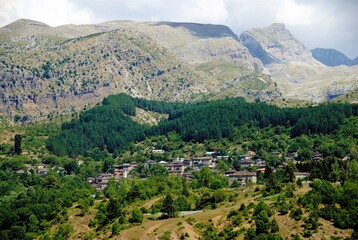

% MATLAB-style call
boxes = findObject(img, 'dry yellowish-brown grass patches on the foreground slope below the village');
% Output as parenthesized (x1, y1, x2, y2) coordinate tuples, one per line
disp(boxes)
(62, 183, 351, 240)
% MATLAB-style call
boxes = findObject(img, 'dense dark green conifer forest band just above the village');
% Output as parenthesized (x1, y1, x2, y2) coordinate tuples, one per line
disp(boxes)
(47, 94, 358, 157)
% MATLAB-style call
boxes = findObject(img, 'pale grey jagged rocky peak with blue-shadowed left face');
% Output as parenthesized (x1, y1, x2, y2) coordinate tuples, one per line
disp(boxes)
(239, 23, 315, 65)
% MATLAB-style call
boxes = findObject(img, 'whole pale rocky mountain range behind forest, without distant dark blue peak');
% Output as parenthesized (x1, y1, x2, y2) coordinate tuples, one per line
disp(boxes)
(0, 19, 358, 122)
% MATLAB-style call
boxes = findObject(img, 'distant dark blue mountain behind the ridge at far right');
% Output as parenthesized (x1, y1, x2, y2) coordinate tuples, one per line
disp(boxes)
(311, 48, 358, 67)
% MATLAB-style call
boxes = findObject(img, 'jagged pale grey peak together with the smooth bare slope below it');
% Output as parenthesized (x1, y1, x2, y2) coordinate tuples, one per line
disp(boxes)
(239, 23, 358, 102)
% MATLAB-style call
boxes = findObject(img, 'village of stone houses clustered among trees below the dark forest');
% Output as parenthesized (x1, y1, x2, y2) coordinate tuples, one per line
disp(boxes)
(86, 149, 314, 191)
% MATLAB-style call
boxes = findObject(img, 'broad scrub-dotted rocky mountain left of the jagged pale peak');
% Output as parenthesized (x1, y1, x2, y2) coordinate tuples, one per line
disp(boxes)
(0, 20, 280, 122)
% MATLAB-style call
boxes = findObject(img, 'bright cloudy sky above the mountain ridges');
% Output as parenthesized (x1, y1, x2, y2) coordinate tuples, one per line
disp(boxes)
(0, 0, 358, 58)
